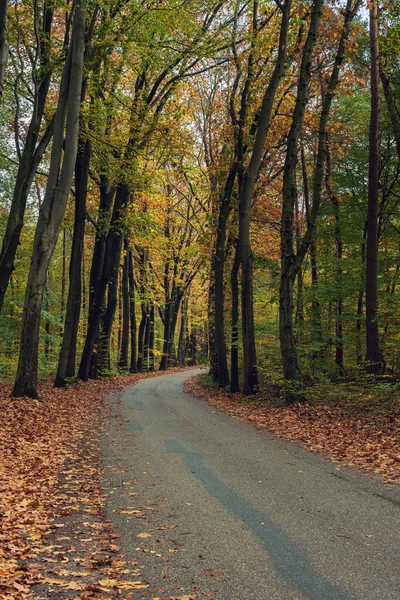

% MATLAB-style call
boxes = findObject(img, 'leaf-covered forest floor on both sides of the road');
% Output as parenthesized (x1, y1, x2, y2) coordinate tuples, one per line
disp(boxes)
(0, 369, 400, 600)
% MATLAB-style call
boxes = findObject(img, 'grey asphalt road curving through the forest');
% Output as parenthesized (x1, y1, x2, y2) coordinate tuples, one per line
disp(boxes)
(103, 371, 400, 600)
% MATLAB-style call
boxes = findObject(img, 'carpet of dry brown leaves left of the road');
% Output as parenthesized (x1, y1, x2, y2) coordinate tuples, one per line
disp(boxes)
(0, 374, 194, 600)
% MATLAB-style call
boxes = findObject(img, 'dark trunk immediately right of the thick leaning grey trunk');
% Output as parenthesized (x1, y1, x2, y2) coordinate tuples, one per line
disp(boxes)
(54, 132, 91, 387)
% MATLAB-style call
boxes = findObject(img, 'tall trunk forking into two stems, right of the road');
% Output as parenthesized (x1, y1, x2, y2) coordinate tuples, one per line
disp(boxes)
(279, 0, 361, 402)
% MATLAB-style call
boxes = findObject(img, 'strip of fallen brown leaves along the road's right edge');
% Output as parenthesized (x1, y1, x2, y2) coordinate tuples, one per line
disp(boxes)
(184, 376, 400, 483)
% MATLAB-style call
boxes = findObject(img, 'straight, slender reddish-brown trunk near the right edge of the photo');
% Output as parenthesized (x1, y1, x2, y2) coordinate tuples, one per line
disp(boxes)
(365, 0, 383, 375)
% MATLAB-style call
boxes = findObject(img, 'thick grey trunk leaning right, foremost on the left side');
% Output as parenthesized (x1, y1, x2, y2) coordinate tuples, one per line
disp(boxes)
(13, 1, 86, 398)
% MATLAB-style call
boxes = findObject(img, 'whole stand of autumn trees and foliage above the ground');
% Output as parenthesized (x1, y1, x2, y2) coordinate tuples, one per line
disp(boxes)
(0, 0, 400, 402)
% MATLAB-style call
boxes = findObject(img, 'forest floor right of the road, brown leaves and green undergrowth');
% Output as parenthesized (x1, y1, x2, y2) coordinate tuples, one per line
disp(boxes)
(184, 375, 400, 484)
